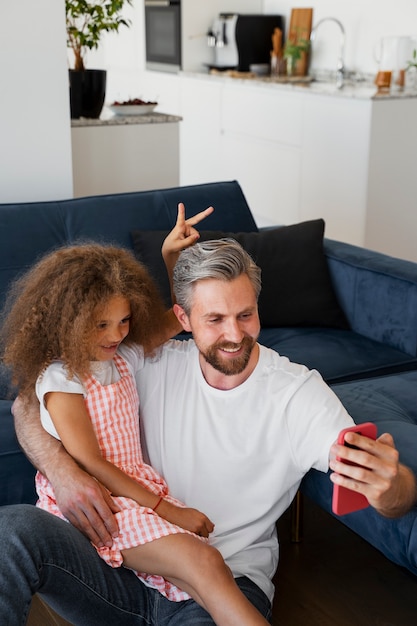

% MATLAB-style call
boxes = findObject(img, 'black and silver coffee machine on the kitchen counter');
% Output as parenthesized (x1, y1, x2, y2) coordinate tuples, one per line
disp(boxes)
(207, 13, 284, 72)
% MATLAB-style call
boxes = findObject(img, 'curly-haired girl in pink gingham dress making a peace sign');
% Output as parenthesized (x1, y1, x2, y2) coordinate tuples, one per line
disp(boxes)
(2, 212, 267, 626)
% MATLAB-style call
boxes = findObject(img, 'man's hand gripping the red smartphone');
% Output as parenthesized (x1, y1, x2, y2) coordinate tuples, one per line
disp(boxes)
(330, 432, 417, 517)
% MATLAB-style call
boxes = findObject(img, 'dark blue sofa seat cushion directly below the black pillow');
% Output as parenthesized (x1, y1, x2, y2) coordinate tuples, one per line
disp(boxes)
(259, 328, 417, 383)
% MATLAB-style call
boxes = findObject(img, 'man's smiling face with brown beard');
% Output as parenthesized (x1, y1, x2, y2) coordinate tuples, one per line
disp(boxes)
(175, 274, 260, 388)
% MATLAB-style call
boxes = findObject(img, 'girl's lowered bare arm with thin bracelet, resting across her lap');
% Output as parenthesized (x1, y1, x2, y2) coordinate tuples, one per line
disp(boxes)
(44, 391, 214, 537)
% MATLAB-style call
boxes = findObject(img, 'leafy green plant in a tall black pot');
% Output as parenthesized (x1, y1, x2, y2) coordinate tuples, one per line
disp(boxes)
(65, 0, 132, 118)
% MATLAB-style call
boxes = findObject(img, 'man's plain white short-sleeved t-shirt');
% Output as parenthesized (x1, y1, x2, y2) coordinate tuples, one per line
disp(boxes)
(136, 340, 353, 601)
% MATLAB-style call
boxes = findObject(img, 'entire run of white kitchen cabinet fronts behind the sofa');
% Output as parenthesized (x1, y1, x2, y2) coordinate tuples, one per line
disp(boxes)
(180, 76, 371, 235)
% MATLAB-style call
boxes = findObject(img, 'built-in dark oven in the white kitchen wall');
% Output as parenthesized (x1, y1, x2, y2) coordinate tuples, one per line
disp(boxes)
(145, 0, 181, 72)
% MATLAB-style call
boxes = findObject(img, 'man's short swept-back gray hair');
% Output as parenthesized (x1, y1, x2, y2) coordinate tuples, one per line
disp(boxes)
(173, 238, 261, 315)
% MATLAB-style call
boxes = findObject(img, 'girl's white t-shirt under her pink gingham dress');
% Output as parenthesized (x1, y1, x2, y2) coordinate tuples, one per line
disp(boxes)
(36, 344, 143, 439)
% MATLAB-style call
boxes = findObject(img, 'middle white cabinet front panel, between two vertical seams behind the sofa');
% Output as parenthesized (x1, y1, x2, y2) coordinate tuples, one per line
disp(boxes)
(221, 84, 303, 226)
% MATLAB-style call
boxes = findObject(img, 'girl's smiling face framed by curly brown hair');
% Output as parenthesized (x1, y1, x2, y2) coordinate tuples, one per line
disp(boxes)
(91, 296, 131, 361)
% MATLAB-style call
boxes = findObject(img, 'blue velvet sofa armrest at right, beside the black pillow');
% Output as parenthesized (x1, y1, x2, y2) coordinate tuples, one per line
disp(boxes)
(324, 239, 417, 356)
